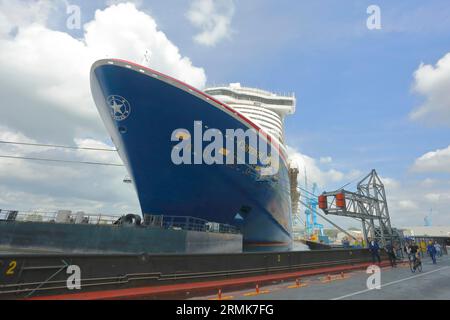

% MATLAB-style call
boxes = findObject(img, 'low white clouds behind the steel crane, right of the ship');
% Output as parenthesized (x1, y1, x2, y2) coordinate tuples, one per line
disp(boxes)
(288, 147, 450, 228)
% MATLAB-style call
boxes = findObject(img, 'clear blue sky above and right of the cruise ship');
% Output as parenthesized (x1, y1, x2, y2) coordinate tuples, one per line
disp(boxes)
(0, 0, 450, 225)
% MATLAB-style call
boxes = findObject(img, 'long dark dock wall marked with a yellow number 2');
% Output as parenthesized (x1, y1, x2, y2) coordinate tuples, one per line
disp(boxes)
(0, 249, 376, 299)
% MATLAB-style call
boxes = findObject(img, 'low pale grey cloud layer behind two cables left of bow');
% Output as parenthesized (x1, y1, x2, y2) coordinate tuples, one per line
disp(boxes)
(0, 126, 139, 214)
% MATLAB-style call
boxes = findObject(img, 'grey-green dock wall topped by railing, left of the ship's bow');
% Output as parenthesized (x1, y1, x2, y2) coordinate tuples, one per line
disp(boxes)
(0, 221, 242, 253)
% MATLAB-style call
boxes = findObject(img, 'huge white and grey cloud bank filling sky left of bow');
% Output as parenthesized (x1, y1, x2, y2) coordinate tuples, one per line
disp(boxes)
(0, 0, 206, 213)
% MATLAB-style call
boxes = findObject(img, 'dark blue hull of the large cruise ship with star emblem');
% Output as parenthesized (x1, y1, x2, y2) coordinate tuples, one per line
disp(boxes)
(91, 60, 292, 249)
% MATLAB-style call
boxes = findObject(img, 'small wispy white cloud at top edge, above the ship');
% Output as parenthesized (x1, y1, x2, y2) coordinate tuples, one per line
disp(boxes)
(186, 0, 235, 46)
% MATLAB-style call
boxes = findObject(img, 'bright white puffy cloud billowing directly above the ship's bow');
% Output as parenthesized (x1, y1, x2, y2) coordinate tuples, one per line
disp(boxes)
(84, 3, 206, 88)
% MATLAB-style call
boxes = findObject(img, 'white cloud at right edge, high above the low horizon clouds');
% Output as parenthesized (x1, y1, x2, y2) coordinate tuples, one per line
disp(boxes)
(410, 53, 450, 126)
